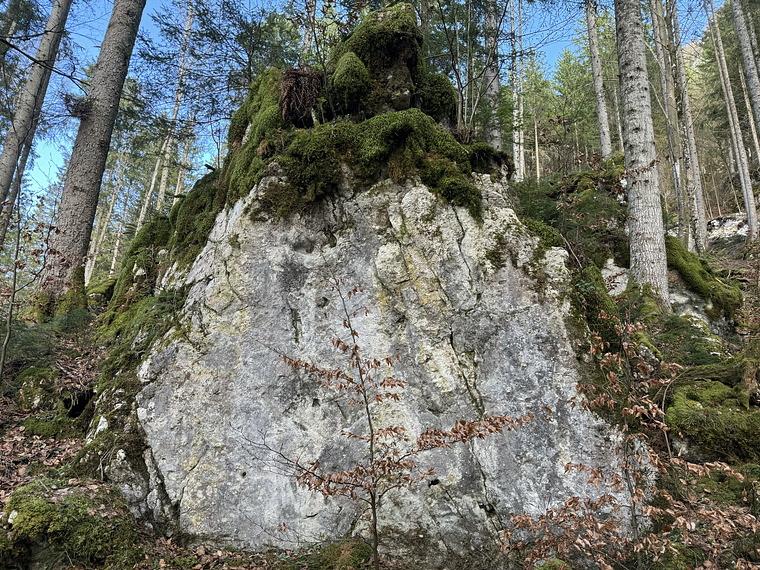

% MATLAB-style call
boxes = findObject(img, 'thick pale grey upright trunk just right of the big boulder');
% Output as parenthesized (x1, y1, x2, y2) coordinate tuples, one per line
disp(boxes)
(615, 0, 670, 307)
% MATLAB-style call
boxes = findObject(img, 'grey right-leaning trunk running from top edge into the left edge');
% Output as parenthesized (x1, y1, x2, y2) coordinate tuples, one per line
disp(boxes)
(0, 0, 71, 202)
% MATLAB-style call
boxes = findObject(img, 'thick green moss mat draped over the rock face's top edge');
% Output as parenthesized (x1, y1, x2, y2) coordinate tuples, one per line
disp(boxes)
(246, 109, 482, 219)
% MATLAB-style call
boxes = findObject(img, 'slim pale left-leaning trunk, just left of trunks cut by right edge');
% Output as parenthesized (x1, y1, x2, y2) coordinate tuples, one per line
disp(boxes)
(703, 0, 758, 241)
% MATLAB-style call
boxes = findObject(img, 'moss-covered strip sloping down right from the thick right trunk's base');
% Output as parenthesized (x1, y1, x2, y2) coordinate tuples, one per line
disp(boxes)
(665, 232, 743, 320)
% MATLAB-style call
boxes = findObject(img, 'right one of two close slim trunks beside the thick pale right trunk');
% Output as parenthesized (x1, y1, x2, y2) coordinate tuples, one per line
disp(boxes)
(666, 0, 707, 252)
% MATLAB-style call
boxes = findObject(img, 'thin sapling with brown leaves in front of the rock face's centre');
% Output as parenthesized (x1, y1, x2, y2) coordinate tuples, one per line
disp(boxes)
(270, 278, 534, 570)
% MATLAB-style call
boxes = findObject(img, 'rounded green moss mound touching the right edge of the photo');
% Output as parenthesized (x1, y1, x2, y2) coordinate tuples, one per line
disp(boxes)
(665, 381, 760, 462)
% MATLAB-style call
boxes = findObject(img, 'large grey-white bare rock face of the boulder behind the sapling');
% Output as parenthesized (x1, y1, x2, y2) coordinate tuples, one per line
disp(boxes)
(101, 169, 618, 567)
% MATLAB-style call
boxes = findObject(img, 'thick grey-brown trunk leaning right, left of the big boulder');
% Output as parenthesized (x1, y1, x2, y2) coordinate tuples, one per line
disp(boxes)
(40, 0, 146, 311)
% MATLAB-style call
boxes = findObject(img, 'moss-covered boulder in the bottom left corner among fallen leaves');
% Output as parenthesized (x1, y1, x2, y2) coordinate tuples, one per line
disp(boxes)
(0, 479, 140, 568)
